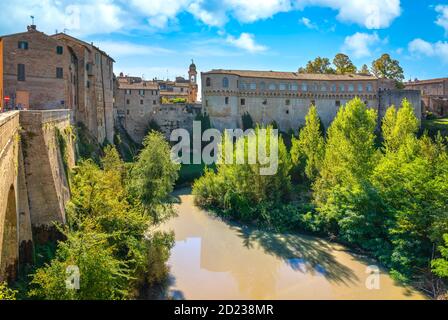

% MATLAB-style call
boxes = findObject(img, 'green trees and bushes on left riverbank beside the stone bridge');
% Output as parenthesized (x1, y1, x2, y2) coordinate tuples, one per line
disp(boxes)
(13, 132, 179, 300)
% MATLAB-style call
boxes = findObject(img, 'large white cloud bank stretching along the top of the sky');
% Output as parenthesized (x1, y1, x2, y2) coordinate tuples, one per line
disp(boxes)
(0, 0, 402, 35)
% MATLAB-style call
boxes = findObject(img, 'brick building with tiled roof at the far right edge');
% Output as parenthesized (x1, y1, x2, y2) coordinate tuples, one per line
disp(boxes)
(405, 78, 448, 116)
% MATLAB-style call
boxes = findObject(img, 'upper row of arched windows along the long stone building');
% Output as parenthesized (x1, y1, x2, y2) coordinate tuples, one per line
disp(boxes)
(205, 77, 373, 92)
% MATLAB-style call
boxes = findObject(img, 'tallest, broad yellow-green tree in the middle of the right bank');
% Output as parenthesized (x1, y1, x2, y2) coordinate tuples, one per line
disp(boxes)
(313, 98, 383, 244)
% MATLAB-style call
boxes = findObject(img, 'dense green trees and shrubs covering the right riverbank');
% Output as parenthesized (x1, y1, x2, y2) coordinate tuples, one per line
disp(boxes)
(193, 99, 448, 297)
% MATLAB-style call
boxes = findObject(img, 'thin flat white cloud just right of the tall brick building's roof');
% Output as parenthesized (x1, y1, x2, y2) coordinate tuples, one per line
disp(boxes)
(95, 41, 173, 57)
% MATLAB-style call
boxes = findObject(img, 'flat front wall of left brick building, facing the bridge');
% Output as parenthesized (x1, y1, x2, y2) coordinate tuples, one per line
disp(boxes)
(0, 25, 75, 110)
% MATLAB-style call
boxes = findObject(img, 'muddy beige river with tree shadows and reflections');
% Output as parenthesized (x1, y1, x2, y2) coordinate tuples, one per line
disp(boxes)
(161, 189, 425, 299)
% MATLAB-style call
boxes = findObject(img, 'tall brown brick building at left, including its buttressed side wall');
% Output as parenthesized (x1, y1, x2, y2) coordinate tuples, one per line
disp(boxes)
(0, 25, 114, 143)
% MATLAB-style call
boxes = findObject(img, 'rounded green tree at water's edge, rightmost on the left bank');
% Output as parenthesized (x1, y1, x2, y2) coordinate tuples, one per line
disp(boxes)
(127, 131, 180, 223)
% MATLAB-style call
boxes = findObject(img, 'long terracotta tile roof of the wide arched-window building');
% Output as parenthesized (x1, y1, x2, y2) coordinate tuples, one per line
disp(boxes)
(203, 69, 378, 81)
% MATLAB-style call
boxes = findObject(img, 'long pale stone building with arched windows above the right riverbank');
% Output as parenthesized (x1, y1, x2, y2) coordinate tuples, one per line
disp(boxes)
(201, 69, 421, 132)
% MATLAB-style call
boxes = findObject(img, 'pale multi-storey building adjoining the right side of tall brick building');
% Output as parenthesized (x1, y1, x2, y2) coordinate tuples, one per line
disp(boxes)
(114, 74, 160, 143)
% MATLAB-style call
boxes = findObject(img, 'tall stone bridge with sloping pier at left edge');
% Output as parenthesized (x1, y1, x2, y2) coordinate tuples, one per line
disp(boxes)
(0, 110, 74, 282)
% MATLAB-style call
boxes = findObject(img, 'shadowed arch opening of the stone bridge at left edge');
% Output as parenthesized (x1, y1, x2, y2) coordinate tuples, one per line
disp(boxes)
(0, 185, 19, 282)
